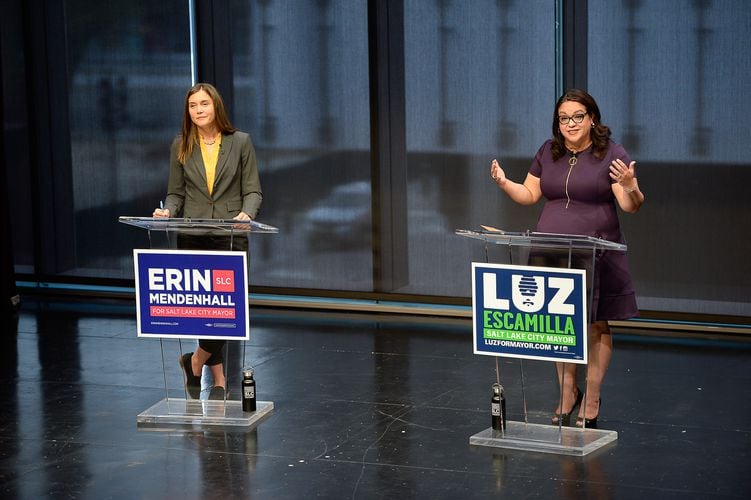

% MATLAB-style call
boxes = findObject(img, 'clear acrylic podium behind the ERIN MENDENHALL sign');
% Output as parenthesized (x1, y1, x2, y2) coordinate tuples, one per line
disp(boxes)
(119, 216, 279, 428)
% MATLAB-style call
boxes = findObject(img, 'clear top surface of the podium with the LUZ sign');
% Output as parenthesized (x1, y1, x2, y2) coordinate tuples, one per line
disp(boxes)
(456, 229, 628, 252)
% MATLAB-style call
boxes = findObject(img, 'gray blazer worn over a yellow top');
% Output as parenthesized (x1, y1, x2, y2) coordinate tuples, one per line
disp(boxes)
(164, 131, 263, 219)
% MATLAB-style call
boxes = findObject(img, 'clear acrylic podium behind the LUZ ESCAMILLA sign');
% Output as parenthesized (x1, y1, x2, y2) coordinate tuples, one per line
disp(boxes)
(456, 228, 627, 456)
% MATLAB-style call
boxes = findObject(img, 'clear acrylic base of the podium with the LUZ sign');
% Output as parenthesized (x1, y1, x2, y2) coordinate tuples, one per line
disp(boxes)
(469, 422, 618, 456)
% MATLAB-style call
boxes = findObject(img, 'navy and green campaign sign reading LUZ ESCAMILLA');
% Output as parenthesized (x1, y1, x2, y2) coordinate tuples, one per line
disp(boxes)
(472, 262, 587, 364)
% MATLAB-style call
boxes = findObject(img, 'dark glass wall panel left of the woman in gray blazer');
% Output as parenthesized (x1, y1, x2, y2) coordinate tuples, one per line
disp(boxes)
(65, 0, 191, 279)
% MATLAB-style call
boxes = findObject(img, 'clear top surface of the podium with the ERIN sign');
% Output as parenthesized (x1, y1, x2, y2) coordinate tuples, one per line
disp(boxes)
(118, 216, 279, 235)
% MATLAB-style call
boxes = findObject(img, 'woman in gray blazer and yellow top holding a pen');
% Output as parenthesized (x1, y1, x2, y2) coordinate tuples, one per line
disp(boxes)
(153, 83, 263, 399)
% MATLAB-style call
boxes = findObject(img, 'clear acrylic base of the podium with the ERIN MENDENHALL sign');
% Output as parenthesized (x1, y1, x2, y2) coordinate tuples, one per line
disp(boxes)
(137, 398, 274, 427)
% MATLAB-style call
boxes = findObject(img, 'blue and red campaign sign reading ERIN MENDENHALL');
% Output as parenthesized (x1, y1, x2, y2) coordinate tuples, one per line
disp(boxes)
(133, 250, 250, 340)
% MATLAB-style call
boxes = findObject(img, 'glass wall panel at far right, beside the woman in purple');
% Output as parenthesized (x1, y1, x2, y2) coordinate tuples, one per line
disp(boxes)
(588, 0, 751, 315)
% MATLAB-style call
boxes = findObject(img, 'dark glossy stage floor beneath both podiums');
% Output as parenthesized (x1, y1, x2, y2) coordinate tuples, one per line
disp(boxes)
(0, 298, 751, 500)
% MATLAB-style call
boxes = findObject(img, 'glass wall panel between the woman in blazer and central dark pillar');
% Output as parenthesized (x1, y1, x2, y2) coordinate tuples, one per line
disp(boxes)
(232, 0, 373, 291)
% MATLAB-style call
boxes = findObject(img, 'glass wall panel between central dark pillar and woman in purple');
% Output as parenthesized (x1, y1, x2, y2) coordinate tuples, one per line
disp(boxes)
(398, 0, 555, 297)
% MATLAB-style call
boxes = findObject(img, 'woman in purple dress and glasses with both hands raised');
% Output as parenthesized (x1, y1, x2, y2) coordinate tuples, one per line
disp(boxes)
(490, 89, 644, 427)
